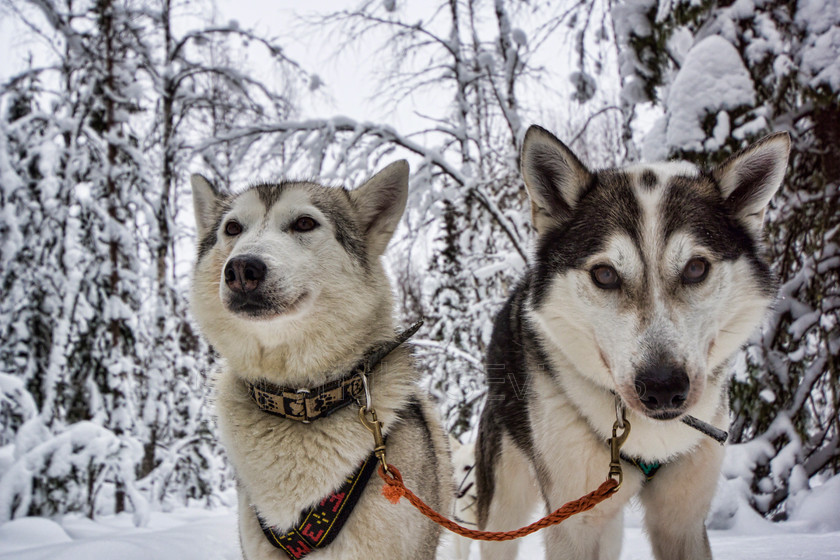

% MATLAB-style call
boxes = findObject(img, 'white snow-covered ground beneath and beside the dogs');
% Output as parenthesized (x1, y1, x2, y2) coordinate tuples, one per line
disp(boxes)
(0, 477, 840, 560)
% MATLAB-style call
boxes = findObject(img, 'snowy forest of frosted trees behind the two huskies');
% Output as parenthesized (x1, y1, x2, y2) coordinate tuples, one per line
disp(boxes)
(0, 0, 840, 548)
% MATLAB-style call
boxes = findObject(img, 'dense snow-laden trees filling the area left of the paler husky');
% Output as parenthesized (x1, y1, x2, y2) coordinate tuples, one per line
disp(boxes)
(0, 0, 306, 523)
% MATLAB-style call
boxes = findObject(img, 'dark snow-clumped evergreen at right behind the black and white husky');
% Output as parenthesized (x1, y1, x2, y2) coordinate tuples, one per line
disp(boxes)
(616, 0, 840, 519)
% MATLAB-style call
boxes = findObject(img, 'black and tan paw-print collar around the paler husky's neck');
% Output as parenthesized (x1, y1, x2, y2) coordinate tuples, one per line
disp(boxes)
(248, 321, 423, 423)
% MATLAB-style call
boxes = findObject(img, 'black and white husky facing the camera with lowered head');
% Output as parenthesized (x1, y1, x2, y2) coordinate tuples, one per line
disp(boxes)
(476, 126, 790, 560)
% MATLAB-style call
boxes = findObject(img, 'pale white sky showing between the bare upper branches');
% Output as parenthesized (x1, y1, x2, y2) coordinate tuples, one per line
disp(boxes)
(0, 0, 650, 158)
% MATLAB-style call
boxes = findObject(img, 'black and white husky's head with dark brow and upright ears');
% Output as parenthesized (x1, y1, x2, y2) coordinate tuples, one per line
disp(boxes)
(521, 127, 790, 420)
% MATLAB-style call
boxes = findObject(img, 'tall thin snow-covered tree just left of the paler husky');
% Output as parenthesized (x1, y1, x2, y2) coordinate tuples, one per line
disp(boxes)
(137, 0, 306, 508)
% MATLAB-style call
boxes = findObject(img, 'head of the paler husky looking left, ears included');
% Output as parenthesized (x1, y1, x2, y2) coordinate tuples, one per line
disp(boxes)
(191, 161, 408, 354)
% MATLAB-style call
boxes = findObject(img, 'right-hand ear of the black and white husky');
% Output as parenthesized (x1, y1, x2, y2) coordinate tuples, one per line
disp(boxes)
(713, 132, 790, 234)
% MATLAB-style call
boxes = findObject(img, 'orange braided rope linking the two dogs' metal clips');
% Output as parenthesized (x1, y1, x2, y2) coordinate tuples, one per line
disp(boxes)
(379, 465, 618, 541)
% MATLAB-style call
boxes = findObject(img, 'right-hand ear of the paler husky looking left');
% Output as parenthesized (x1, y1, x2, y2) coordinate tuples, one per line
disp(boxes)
(350, 159, 408, 257)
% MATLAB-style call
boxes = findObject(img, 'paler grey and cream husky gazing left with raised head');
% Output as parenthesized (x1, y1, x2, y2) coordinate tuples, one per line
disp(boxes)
(191, 161, 452, 560)
